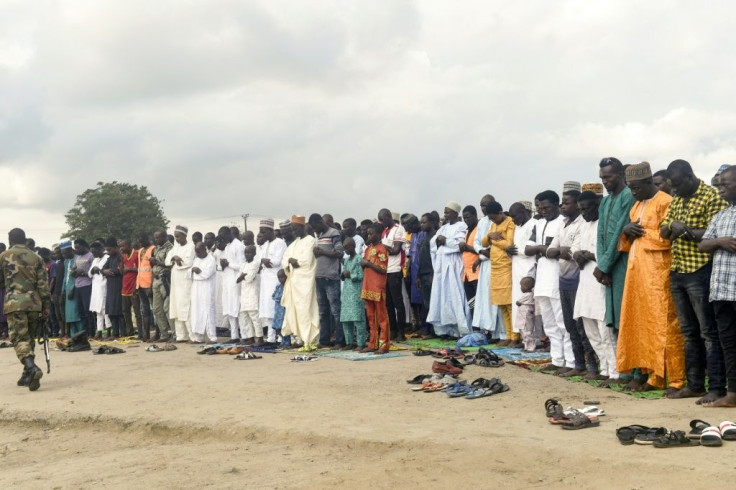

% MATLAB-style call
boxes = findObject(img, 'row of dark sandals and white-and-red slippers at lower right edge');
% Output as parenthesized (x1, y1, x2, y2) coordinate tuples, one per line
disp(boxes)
(616, 419, 736, 448)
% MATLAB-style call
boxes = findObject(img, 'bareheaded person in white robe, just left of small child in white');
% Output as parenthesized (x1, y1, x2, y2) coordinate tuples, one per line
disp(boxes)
(217, 226, 245, 341)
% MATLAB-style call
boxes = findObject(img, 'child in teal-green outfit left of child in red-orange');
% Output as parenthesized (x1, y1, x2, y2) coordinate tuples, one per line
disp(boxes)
(340, 237, 366, 350)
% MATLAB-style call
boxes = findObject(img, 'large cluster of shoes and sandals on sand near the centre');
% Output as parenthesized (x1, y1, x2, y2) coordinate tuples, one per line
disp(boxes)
(407, 347, 510, 400)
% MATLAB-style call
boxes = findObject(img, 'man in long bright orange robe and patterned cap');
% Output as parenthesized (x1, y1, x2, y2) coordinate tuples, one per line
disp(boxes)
(616, 162, 685, 391)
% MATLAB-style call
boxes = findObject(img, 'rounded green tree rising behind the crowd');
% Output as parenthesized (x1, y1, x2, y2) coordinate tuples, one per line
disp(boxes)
(62, 182, 169, 241)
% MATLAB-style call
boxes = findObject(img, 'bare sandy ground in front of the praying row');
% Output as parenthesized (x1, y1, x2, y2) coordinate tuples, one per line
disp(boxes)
(0, 345, 736, 489)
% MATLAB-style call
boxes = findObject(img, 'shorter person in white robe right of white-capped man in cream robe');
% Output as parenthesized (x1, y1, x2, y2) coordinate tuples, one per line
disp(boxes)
(189, 242, 217, 342)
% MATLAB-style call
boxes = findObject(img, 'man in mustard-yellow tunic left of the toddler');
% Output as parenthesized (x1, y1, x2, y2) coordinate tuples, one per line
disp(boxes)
(482, 201, 521, 347)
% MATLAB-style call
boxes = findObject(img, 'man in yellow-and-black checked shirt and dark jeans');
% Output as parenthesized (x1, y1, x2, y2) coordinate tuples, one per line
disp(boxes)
(660, 160, 726, 404)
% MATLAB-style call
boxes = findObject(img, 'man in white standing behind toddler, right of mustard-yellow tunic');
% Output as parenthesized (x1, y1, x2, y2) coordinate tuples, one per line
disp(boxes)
(509, 202, 538, 340)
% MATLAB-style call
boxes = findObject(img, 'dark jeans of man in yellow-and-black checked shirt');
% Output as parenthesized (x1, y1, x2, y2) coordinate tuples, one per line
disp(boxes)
(670, 263, 726, 395)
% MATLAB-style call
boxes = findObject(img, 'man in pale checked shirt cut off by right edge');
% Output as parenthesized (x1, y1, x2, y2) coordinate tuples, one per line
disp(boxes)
(698, 166, 736, 407)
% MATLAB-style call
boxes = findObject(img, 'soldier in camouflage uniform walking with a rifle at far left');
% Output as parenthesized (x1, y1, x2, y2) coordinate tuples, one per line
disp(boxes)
(0, 228, 51, 391)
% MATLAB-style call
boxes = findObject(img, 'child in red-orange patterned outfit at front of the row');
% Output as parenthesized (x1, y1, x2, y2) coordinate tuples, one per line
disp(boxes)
(360, 223, 390, 354)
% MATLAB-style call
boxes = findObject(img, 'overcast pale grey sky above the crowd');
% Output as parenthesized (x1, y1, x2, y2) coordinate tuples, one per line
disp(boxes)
(0, 0, 736, 245)
